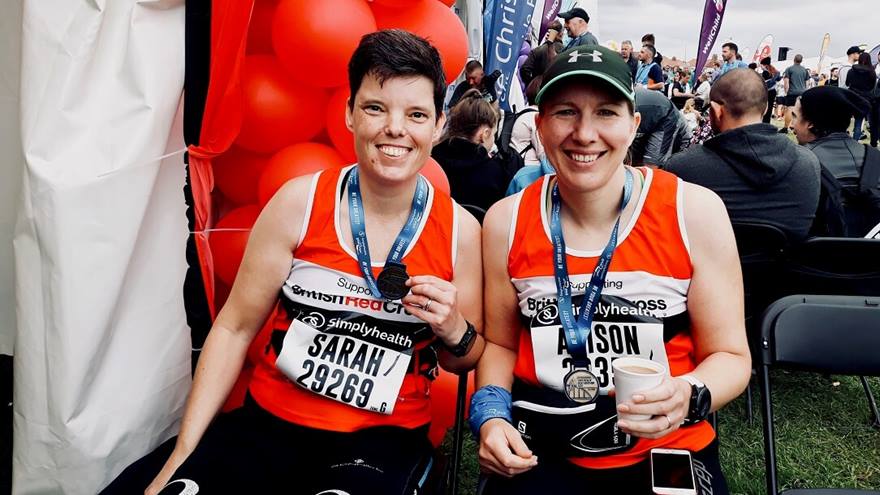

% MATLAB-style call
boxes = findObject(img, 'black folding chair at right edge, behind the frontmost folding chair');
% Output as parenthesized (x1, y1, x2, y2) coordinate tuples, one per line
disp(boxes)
(782, 237, 880, 428)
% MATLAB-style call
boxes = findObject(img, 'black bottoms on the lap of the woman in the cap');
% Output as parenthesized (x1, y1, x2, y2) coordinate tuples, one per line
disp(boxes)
(483, 440, 729, 495)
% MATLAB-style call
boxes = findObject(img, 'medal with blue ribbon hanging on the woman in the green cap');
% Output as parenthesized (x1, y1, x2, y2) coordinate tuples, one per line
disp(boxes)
(550, 168, 633, 404)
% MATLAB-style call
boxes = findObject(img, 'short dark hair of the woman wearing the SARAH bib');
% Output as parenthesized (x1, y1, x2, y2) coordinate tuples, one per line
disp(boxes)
(348, 29, 446, 120)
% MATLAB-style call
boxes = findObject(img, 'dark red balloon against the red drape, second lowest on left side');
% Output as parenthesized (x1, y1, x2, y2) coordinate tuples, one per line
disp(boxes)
(211, 146, 269, 205)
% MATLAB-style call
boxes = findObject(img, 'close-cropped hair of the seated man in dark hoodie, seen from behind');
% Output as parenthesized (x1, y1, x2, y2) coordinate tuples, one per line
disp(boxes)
(709, 68, 767, 119)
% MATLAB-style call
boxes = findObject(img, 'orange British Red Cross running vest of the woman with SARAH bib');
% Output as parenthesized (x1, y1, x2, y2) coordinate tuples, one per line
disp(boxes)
(250, 167, 457, 432)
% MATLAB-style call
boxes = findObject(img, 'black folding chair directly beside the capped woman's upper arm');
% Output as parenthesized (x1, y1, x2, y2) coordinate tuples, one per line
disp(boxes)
(728, 222, 788, 424)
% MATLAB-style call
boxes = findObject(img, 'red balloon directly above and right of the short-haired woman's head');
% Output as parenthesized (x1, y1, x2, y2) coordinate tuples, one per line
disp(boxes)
(370, 0, 468, 83)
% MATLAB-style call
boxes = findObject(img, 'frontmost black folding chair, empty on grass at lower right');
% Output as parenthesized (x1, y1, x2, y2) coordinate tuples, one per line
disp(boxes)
(760, 295, 880, 495)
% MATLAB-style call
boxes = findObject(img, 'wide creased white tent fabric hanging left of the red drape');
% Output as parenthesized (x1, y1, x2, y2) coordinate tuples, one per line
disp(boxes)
(13, 0, 190, 494)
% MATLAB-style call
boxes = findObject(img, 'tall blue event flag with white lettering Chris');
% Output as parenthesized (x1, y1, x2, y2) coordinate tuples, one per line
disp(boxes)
(483, 0, 535, 111)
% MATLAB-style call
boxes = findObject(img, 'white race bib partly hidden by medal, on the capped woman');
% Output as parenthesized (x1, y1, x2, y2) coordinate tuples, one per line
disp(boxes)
(530, 294, 669, 394)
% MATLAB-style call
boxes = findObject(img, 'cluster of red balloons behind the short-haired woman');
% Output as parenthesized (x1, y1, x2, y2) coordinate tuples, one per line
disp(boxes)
(209, 0, 468, 442)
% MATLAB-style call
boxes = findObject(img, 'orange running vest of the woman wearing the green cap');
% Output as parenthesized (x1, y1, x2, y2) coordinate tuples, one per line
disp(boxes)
(508, 168, 715, 468)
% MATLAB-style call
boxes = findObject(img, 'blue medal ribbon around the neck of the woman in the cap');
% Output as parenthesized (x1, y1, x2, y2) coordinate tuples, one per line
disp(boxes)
(550, 168, 633, 368)
